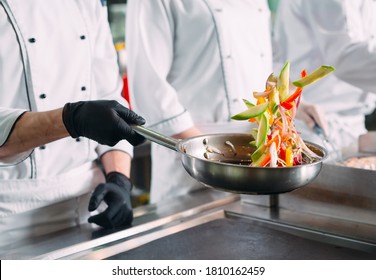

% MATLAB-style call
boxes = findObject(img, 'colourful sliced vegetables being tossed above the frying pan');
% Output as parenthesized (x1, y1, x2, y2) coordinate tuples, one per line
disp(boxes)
(232, 62, 335, 167)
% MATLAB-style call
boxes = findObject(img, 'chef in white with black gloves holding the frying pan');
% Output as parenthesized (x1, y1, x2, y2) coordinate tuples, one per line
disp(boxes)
(0, 0, 144, 248)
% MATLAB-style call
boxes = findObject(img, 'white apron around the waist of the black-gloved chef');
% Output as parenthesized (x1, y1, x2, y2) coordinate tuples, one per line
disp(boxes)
(0, 163, 104, 250)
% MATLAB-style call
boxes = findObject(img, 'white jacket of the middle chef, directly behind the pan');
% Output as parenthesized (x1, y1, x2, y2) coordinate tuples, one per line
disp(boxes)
(126, 0, 272, 202)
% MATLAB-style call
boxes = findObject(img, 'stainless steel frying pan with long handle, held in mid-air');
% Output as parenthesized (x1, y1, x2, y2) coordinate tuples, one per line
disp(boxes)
(133, 126, 327, 194)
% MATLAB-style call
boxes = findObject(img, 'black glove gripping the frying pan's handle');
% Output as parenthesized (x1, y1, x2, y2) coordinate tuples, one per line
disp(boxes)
(63, 100, 145, 146)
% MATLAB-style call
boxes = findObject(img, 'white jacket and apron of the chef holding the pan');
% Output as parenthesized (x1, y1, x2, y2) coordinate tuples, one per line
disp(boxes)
(0, 0, 133, 244)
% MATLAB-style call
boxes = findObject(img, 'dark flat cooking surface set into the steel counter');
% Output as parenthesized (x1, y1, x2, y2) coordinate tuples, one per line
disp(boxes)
(106, 214, 376, 260)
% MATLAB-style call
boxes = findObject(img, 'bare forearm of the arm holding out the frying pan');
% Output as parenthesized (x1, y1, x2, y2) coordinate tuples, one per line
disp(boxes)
(0, 109, 69, 158)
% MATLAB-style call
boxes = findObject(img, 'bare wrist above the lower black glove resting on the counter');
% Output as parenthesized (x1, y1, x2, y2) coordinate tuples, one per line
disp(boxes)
(101, 150, 132, 178)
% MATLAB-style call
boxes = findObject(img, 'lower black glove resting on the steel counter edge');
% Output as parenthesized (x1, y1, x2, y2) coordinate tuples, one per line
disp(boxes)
(88, 172, 133, 229)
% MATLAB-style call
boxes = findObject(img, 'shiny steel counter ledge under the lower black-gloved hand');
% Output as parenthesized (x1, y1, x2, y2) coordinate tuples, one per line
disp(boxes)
(0, 189, 238, 259)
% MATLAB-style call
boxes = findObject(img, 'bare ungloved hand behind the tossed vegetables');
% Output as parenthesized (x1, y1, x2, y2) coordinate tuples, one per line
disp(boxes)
(296, 102, 329, 135)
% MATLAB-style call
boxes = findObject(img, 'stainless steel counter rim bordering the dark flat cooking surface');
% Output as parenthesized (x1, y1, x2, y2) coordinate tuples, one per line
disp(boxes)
(0, 182, 376, 259)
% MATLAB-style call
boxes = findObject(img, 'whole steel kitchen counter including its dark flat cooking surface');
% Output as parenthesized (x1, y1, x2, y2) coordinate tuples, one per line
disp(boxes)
(0, 166, 376, 259)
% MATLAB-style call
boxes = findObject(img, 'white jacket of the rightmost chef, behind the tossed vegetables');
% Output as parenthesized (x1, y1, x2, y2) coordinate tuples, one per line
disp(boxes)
(273, 0, 376, 152)
